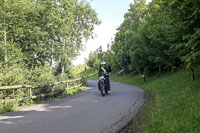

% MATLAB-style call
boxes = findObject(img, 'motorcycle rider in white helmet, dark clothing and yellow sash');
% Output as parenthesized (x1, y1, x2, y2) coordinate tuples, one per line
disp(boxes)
(98, 61, 112, 91)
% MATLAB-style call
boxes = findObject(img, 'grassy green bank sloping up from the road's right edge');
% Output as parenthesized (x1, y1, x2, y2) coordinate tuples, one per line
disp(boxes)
(91, 69, 200, 133)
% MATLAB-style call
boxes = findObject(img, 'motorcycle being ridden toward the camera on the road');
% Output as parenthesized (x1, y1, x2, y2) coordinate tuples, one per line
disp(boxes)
(98, 72, 108, 97)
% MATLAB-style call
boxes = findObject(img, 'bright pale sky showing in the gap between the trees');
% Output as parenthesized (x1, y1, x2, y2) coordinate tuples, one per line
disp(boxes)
(72, 0, 151, 65)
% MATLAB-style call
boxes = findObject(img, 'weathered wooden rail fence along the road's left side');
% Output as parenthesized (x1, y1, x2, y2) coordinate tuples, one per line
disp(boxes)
(0, 78, 86, 103)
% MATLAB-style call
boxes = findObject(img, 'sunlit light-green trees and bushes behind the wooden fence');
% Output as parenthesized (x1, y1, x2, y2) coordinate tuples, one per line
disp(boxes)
(0, 0, 100, 86)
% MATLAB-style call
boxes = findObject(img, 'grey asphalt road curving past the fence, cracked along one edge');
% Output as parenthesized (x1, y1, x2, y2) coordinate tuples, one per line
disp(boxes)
(0, 81, 144, 133)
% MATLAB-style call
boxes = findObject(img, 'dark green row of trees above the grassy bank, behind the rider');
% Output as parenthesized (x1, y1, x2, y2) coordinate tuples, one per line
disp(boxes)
(87, 0, 200, 80)
